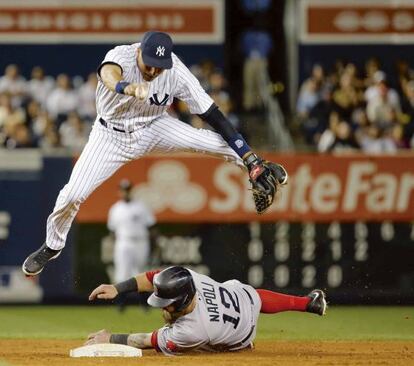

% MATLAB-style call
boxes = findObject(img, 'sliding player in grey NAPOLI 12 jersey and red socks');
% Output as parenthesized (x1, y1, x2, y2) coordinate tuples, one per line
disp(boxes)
(86, 266, 327, 355)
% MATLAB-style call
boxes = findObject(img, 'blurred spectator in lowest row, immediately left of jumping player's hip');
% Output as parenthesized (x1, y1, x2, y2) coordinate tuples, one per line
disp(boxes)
(59, 112, 90, 154)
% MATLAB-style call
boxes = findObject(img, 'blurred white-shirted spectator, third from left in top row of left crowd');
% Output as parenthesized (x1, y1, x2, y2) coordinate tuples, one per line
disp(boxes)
(46, 74, 78, 125)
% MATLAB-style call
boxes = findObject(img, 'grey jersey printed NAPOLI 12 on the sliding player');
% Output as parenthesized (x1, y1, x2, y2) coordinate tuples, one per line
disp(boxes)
(152, 270, 262, 355)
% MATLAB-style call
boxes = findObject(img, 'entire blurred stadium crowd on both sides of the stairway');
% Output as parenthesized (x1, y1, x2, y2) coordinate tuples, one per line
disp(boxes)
(0, 58, 414, 154)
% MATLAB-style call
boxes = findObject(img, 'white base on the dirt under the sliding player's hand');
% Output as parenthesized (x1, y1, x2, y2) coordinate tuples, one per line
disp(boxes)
(69, 343, 142, 357)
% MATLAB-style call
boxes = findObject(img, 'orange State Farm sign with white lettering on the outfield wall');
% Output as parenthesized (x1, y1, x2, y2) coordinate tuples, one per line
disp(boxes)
(78, 154, 414, 222)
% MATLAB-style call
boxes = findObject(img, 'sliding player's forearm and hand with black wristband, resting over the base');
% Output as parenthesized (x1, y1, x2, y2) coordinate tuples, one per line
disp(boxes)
(85, 329, 152, 349)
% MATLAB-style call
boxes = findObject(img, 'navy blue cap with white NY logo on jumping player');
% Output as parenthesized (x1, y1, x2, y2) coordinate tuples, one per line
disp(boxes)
(140, 31, 173, 69)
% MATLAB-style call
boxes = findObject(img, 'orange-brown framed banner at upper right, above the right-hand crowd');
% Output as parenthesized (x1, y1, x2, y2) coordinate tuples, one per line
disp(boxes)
(300, 0, 414, 43)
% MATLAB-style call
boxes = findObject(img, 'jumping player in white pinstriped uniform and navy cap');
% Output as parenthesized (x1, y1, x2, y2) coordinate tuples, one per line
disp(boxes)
(22, 31, 288, 276)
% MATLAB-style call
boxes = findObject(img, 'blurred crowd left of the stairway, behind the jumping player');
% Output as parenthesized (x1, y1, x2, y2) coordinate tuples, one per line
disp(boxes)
(0, 62, 234, 154)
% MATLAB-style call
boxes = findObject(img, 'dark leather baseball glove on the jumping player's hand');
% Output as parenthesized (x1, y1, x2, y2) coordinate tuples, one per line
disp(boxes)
(244, 154, 288, 214)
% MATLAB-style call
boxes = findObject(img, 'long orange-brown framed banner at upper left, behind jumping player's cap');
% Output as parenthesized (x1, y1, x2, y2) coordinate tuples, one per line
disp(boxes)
(0, 0, 224, 43)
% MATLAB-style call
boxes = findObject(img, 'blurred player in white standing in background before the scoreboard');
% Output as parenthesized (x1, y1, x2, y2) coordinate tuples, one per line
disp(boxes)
(108, 179, 156, 310)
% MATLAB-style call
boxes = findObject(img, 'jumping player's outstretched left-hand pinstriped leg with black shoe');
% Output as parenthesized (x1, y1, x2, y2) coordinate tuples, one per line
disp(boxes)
(22, 123, 132, 276)
